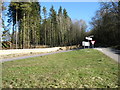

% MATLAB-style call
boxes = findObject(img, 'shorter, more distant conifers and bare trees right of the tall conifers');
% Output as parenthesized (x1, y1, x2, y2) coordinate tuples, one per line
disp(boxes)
(41, 6, 87, 46)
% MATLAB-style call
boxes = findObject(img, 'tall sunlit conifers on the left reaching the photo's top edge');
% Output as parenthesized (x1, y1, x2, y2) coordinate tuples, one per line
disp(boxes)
(8, 2, 41, 48)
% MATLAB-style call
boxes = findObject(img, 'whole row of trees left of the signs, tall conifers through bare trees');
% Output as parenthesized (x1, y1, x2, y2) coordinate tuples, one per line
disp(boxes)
(2, 2, 87, 48)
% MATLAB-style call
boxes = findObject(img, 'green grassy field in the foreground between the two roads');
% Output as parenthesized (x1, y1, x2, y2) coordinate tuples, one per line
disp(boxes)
(2, 49, 118, 88)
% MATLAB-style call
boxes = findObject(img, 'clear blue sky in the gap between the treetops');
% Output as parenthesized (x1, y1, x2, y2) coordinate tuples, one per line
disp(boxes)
(41, 2, 99, 30)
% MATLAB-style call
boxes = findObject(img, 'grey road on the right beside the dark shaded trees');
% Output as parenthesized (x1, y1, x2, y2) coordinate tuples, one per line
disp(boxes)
(95, 48, 120, 63)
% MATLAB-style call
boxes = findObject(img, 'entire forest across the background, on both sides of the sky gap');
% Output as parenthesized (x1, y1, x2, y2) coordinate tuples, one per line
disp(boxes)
(2, 2, 120, 48)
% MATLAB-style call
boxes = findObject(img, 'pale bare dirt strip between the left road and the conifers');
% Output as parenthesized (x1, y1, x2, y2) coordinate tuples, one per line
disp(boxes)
(0, 46, 78, 60)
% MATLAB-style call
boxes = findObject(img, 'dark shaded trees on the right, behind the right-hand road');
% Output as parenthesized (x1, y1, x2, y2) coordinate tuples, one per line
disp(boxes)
(90, 2, 120, 46)
